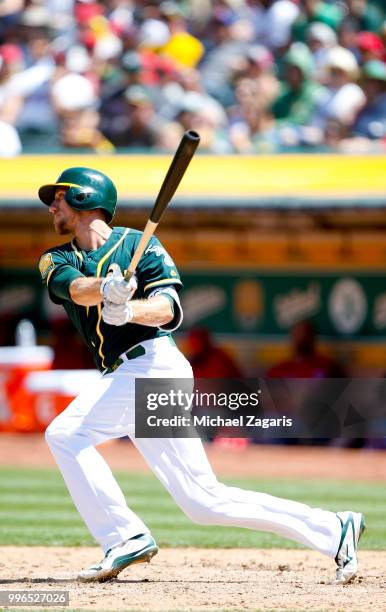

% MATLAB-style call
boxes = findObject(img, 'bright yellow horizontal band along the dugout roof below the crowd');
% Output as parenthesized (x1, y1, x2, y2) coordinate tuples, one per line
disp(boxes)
(0, 155, 386, 203)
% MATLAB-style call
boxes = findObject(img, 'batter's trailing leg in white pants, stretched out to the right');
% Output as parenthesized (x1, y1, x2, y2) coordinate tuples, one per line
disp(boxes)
(133, 438, 341, 557)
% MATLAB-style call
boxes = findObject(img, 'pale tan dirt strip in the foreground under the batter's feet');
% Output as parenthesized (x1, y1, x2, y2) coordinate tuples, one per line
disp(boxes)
(0, 547, 386, 612)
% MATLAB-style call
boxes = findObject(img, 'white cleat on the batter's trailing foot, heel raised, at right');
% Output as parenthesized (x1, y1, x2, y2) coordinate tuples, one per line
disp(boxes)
(333, 512, 366, 584)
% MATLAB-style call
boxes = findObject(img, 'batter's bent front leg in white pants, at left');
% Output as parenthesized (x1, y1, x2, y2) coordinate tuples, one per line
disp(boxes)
(46, 375, 149, 552)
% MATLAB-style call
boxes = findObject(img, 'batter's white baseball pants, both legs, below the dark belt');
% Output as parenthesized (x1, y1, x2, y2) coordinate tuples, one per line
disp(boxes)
(46, 337, 341, 557)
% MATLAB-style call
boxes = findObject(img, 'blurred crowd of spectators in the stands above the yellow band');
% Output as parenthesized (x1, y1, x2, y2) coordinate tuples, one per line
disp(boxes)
(0, 0, 386, 156)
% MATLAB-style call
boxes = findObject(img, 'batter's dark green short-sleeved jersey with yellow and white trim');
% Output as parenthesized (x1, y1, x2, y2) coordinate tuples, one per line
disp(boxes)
(39, 227, 182, 371)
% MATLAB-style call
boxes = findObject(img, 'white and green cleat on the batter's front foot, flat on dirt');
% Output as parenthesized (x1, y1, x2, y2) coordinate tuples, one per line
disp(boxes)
(78, 533, 158, 582)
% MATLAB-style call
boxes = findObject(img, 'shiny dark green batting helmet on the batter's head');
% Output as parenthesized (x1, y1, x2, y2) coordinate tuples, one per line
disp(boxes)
(39, 168, 117, 223)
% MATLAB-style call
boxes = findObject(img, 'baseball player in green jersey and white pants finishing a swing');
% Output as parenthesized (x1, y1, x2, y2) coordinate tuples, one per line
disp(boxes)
(39, 168, 364, 584)
